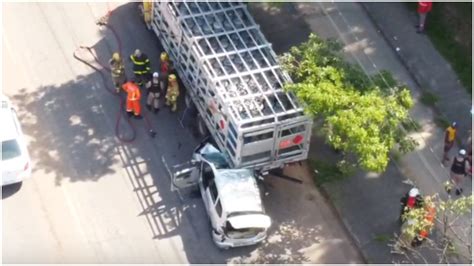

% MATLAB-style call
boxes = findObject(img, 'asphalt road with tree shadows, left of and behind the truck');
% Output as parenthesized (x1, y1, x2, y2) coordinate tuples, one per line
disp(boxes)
(2, 3, 361, 263)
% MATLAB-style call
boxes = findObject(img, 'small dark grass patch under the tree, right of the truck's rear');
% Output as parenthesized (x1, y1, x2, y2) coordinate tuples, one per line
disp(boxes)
(309, 159, 348, 187)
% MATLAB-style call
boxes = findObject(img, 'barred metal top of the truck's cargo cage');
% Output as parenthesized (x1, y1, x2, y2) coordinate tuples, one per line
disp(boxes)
(155, 0, 302, 126)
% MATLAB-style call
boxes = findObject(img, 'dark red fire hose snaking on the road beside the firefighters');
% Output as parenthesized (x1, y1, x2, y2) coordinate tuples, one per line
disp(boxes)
(73, 16, 156, 143)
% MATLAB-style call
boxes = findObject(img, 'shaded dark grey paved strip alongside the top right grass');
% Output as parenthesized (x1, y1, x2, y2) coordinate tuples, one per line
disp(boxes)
(361, 2, 472, 145)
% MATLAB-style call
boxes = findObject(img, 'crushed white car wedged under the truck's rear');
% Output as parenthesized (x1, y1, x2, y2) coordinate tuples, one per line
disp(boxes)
(168, 143, 271, 249)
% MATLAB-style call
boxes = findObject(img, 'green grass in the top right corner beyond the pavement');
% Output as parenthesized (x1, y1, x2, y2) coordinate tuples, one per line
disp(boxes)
(408, 2, 472, 94)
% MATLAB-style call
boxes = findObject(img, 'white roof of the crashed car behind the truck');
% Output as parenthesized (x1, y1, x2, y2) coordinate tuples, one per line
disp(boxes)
(215, 169, 263, 213)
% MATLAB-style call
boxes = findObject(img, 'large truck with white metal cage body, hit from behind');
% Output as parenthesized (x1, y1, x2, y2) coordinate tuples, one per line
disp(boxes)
(142, 1, 312, 174)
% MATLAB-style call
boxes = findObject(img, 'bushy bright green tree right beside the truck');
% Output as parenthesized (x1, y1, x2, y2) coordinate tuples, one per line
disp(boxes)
(281, 34, 415, 172)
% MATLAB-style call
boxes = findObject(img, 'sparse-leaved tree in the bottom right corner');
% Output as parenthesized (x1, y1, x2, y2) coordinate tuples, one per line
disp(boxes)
(391, 190, 472, 263)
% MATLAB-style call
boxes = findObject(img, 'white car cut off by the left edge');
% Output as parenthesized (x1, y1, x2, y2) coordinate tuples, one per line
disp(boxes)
(0, 94, 31, 186)
